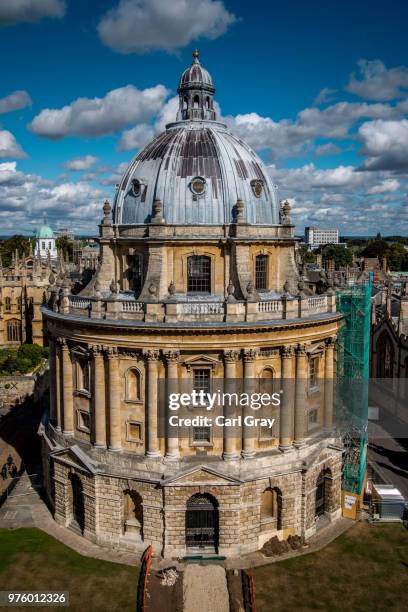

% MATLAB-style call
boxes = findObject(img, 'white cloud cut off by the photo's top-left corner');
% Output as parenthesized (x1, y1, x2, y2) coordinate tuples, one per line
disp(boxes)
(0, 0, 66, 26)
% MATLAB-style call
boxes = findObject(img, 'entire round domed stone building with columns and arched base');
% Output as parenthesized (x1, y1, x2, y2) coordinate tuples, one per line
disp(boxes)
(42, 52, 342, 557)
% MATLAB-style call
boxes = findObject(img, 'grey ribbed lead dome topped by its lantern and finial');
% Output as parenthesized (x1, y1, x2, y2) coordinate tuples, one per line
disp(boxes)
(114, 52, 279, 225)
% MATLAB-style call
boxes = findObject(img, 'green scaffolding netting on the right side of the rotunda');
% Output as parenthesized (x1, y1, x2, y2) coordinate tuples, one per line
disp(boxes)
(336, 275, 372, 494)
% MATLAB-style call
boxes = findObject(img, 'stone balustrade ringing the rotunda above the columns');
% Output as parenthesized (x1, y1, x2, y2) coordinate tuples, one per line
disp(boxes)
(49, 293, 336, 323)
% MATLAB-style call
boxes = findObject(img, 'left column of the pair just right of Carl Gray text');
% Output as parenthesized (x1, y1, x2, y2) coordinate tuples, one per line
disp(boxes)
(279, 346, 295, 451)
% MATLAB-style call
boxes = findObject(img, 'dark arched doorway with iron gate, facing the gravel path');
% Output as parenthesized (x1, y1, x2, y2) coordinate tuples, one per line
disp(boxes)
(186, 493, 218, 551)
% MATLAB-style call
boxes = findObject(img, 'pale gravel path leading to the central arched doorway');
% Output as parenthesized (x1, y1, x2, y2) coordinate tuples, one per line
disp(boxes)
(183, 563, 230, 612)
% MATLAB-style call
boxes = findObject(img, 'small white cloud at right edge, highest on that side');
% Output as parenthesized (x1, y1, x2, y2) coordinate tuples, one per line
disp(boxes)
(346, 59, 408, 100)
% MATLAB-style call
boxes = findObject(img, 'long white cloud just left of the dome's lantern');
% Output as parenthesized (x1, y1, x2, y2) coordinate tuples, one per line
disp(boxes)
(29, 85, 168, 140)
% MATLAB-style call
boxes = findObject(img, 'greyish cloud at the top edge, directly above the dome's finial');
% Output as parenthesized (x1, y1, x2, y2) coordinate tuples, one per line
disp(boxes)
(98, 0, 236, 53)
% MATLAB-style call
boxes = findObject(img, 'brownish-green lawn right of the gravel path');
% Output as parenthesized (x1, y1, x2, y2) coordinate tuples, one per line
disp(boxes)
(253, 523, 408, 612)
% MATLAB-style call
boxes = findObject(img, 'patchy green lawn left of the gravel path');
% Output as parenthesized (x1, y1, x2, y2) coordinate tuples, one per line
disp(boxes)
(0, 529, 139, 612)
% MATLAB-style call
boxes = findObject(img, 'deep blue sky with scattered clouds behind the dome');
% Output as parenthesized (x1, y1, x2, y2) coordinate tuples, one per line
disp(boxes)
(0, 0, 408, 234)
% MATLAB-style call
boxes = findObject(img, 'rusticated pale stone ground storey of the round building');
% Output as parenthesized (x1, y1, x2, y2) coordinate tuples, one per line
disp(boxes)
(43, 437, 341, 558)
